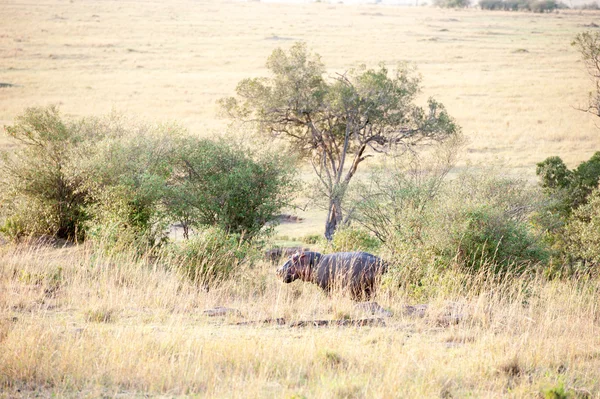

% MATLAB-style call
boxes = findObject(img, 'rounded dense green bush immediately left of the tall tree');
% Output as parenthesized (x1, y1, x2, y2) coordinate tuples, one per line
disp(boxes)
(166, 138, 296, 238)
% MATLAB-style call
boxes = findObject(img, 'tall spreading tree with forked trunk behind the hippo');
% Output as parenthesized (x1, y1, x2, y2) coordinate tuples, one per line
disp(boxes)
(220, 43, 459, 240)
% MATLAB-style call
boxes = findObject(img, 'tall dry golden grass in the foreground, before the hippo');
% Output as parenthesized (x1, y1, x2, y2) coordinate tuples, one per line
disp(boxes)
(0, 246, 600, 398)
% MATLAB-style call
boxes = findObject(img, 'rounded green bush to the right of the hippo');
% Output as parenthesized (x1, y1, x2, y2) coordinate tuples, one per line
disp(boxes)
(430, 171, 548, 274)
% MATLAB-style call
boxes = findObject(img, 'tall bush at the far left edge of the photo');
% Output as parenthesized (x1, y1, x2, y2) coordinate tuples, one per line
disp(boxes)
(0, 106, 87, 240)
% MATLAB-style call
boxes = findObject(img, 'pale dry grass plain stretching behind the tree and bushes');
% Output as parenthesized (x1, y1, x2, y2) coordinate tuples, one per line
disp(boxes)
(0, 0, 600, 172)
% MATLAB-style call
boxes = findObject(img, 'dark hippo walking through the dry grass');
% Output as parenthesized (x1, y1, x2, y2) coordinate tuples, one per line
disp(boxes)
(277, 252, 387, 300)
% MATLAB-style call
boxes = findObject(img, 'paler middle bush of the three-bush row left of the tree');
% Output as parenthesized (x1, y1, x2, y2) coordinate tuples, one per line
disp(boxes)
(81, 123, 178, 252)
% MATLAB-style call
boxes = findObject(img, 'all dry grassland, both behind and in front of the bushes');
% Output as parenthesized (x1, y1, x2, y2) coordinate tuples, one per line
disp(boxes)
(0, 0, 600, 398)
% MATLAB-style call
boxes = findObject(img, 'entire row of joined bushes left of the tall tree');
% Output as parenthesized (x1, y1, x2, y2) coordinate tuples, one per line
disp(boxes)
(0, 107, 296, 252)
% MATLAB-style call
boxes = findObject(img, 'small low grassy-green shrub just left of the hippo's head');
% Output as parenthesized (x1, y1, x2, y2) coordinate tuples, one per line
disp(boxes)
(170, 227, 258, 286)
